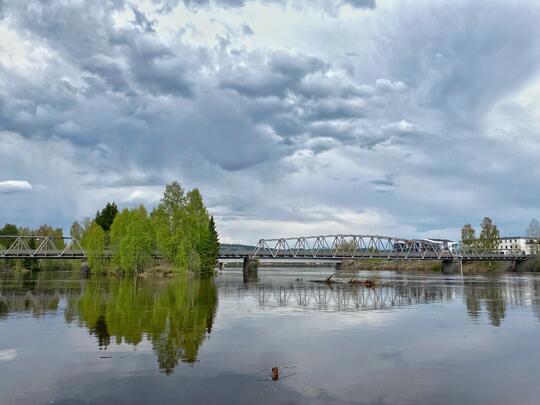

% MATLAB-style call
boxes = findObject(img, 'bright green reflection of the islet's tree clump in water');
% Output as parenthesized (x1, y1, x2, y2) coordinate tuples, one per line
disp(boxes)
(66, 278, 217, 374)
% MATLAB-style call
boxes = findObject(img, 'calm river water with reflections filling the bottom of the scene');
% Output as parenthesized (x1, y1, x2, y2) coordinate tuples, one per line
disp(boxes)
(0, 268, 540, 404)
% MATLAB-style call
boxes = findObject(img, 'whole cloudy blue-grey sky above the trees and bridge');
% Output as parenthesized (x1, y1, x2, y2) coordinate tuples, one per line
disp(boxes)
(0, 0, 540, 243)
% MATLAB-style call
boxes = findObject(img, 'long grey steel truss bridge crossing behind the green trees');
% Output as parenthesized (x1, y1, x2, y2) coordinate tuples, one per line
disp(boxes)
(0, 235, 532, 262)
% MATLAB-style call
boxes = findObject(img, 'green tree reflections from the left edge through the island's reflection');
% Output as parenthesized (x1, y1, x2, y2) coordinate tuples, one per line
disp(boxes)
(0, 275, 218, 373)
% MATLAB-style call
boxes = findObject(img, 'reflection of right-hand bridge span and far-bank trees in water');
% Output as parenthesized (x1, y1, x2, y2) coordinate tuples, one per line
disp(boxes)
(218, 275, 540, 326)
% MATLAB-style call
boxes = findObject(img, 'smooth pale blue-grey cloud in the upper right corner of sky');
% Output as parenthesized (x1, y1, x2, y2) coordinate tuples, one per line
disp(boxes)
(383, 1, 540, 128)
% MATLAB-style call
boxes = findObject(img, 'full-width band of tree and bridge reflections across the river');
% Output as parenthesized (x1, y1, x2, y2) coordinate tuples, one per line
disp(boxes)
(0, 272, 540, 373)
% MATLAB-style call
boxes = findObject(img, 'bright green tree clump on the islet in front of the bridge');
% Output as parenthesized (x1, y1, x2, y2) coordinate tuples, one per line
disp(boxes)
(75, 182, 219, 275)
